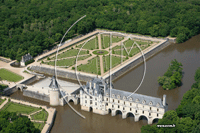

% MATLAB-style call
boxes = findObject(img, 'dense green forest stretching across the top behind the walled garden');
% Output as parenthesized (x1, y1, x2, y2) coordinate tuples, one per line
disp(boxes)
(0, 0, 200, 61)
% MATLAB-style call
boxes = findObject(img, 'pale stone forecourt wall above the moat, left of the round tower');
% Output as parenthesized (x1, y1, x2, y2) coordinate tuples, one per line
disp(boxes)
(23, 90, 50, 102)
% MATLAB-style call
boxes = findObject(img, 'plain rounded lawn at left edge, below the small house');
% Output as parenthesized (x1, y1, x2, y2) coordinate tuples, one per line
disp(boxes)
(0, 68, 23, 82)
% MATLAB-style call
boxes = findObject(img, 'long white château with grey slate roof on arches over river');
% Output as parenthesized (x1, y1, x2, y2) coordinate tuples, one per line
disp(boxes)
(80, 78, 168, 124)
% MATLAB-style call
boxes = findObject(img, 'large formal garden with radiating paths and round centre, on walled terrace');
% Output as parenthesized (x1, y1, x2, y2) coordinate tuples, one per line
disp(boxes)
(41, 34, 158, 75)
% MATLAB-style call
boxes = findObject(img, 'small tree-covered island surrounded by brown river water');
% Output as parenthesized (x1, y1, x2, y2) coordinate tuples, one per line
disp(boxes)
(158, 59, 183, 90)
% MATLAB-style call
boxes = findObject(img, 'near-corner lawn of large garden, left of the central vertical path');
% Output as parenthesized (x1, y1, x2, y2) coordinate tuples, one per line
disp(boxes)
(77, 57, 100, 74)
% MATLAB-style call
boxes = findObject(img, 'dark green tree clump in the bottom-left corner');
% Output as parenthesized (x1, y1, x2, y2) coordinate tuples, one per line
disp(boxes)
(0, 111, 40, 133)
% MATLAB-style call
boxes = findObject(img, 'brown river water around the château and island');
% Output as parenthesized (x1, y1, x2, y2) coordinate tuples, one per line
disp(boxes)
(11, 35, 200, 133)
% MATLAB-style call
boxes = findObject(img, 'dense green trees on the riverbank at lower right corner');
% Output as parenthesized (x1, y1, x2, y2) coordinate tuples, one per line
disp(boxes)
(141, 68, 200, 133)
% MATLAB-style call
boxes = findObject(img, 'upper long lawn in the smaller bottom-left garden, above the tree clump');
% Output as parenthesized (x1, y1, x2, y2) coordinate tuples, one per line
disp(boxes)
(3, 102, 40, 114)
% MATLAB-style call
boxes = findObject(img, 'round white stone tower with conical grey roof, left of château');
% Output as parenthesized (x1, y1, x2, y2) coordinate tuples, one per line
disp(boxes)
(49, 76, 60, 106)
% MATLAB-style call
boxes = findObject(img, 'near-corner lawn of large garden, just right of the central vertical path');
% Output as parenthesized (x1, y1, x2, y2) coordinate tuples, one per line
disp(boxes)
(103, 55, 126, 72)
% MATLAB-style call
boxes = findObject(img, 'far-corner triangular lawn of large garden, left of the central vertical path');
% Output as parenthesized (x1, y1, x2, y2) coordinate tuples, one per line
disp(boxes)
(78, 37, 99, 50)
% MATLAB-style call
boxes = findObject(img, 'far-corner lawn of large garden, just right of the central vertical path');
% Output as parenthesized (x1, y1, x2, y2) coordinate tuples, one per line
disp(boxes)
(101, 35, 124, 49)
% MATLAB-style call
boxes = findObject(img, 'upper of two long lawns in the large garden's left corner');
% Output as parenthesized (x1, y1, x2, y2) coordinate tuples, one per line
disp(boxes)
(51, 49, 87, 60)
